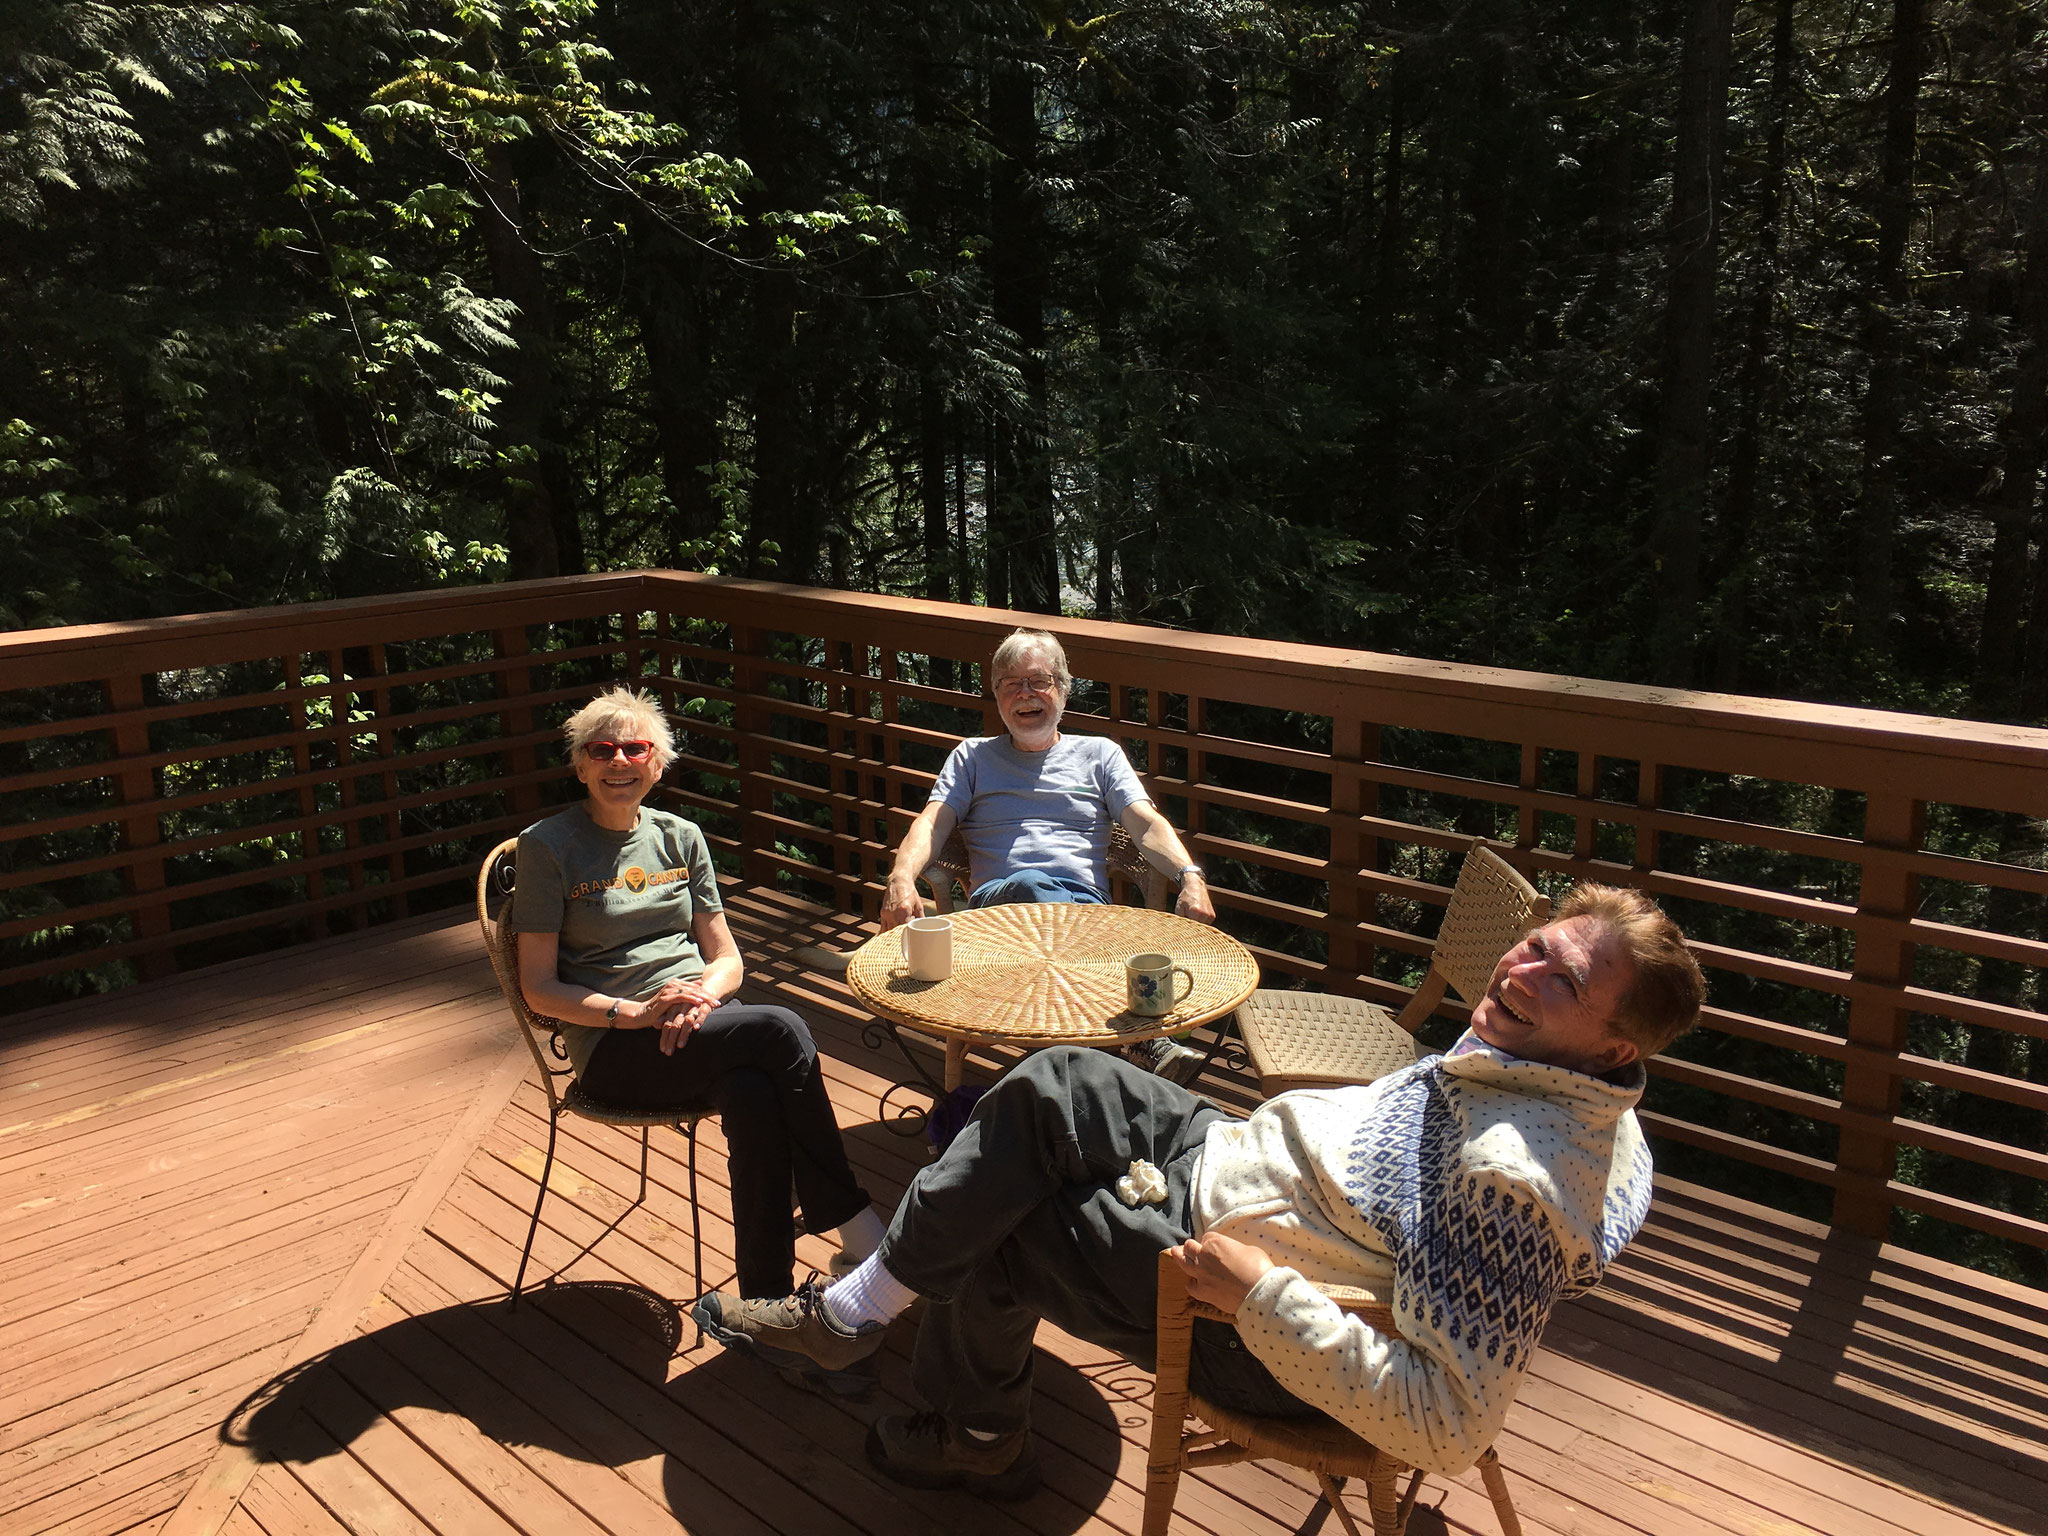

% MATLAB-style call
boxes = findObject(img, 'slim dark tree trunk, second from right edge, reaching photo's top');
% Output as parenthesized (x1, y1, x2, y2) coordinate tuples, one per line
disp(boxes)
(1853, 0, 1927, 655)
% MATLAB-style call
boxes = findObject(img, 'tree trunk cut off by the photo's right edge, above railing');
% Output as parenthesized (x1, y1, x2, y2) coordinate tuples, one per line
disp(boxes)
(1976, 144, 2048, 715)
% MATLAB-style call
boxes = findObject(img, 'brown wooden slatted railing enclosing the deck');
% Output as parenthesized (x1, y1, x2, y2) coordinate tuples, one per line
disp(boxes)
(0, 571, 2048, 1269)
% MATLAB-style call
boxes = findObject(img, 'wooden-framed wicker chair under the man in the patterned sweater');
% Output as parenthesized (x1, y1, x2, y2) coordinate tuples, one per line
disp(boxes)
(1143, 1253, 1522, 1536)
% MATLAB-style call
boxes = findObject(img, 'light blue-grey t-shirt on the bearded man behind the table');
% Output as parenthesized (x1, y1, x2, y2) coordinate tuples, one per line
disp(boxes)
(932, 733, 1151, 895)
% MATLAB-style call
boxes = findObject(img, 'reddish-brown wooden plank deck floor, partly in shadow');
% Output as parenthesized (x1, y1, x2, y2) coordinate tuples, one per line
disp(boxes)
(0, 897, 2048, 1536)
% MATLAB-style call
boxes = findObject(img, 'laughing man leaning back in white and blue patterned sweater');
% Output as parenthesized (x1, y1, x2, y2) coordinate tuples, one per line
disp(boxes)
(696, 885, 1706, 1497)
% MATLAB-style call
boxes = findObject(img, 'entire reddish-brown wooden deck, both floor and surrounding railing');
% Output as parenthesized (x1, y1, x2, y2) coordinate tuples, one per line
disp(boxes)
(0, 571, 2048, 1536)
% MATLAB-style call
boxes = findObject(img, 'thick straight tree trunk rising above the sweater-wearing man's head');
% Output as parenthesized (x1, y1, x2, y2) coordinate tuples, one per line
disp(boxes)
(1651, 0, 1735, 686)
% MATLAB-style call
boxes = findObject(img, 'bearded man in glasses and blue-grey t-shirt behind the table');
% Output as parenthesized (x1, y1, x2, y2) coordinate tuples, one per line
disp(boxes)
(881, 629, 1217, 1081)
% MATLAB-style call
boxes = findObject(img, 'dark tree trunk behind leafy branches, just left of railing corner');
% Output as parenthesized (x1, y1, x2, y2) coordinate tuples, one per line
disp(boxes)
(471, 143, 584, 580)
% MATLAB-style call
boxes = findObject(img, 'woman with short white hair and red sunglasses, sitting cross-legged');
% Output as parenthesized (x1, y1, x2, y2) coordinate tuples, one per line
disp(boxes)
(508, 688, 883, 1296)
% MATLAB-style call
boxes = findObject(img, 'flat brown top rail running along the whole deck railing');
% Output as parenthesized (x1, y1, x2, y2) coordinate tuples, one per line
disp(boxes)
(0, 571, 2048, 815)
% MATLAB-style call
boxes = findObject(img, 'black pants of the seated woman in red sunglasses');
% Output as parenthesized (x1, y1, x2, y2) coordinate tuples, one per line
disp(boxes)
(582, 1004, 868, 1296)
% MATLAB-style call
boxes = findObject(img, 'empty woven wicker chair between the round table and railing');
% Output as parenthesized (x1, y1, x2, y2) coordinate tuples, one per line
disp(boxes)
(1237, 838, 1550, 1098)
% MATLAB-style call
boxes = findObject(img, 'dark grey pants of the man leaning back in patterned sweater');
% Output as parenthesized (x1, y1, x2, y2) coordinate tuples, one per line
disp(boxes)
(881, 1047, 1311, 1434)
